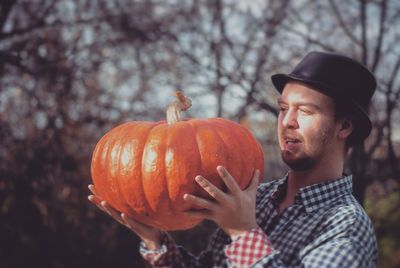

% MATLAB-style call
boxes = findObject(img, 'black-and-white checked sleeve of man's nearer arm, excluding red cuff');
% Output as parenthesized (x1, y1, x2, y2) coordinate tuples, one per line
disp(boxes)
(252, 208, 377, 268)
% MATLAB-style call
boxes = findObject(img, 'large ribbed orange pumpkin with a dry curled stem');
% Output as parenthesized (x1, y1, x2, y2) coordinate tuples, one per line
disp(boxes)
(91, 92, 264, 231)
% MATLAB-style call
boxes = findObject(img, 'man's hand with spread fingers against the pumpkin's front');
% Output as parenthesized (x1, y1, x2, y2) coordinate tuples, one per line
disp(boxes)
(184, 166, 260, 239)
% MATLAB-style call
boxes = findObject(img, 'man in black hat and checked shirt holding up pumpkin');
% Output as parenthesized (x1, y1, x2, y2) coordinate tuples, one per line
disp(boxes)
(89, 52, 377, 267)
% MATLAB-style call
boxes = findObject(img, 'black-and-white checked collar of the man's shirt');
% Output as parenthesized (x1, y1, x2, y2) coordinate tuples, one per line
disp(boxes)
(272, 174, 353, 213)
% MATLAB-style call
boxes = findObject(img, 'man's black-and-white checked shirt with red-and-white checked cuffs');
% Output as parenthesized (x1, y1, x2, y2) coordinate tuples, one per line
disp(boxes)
(140, 176, 377, 268)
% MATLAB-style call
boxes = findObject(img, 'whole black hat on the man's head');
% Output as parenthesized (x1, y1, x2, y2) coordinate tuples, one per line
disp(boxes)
(271, 52, 376, 143)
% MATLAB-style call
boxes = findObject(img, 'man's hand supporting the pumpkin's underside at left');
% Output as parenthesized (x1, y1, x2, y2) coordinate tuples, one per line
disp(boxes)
(88, 184, 161, 250)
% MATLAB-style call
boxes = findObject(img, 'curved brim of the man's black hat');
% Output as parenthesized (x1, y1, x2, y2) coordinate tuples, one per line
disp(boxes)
(271, 74, 372, 144)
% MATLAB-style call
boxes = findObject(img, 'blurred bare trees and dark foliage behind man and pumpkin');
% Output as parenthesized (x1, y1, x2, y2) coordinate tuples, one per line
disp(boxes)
(0, 0, 400, 267)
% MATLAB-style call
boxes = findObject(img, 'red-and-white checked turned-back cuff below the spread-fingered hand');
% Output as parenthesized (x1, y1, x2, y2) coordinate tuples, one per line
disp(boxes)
(224, 227, 273, 267)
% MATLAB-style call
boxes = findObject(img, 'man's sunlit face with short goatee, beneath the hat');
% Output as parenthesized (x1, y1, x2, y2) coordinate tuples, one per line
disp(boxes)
(278, 82, 336, 171)
